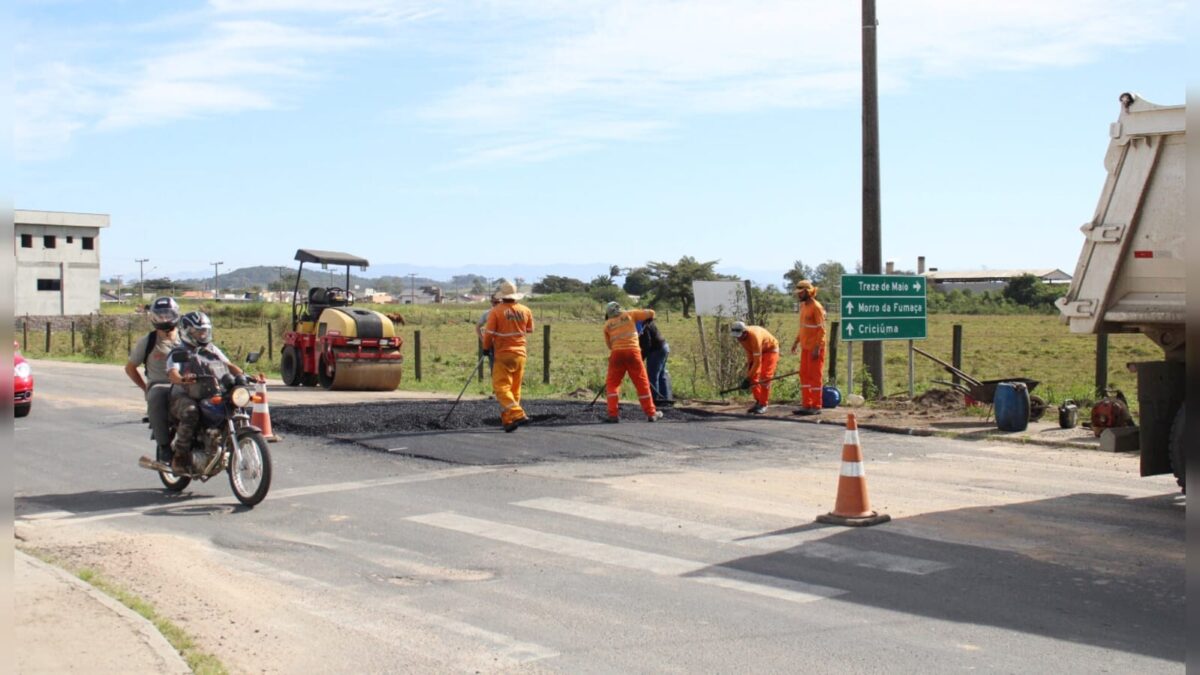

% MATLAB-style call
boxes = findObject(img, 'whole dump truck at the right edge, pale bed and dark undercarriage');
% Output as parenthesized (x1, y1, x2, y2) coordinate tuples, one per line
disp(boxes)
(1057, 94, 1187, 488)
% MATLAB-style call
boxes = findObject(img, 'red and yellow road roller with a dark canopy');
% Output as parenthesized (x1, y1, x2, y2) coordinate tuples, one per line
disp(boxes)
(280, 249, 404, 392)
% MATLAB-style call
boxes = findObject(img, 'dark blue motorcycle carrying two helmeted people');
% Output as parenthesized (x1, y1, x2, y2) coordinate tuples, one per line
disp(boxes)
(138, 353, 271, 507)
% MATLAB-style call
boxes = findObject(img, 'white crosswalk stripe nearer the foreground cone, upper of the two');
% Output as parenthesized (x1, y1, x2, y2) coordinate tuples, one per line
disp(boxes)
(515, 497, 952, 574)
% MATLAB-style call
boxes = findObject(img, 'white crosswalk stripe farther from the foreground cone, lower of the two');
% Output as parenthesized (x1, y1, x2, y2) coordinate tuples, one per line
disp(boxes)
(406, 512, 846, 603)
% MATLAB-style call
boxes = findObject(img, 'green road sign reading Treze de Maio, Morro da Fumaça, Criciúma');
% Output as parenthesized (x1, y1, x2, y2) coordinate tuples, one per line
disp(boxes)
(840, 274, 926, 341)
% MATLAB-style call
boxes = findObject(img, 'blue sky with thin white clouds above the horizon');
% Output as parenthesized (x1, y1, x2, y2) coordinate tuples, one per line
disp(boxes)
(12, 0, 1187, 283)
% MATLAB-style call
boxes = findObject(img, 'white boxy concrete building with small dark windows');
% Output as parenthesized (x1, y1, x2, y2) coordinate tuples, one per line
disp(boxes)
(13, 209, 108, 316)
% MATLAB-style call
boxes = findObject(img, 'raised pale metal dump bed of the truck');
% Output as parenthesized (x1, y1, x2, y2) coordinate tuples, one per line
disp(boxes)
(1057, 94, 1186, 354)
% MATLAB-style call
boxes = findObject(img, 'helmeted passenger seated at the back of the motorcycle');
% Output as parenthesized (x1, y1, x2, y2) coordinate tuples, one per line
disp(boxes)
(125, 297, 180, 462)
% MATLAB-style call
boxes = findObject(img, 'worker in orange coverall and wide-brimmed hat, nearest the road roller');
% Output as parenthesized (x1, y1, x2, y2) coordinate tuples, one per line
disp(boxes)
(484, 280, 533, 432)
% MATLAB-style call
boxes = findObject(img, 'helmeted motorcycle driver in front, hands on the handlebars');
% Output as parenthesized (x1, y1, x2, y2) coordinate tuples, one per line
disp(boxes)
(167, 311, 242, 473)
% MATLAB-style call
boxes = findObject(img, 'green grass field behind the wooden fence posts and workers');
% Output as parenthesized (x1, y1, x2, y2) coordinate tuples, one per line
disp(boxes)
(17, 303, 1162, 406)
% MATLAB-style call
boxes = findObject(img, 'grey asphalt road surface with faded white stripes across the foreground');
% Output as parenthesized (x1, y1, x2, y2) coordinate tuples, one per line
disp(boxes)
(13, 362, 1187, 673)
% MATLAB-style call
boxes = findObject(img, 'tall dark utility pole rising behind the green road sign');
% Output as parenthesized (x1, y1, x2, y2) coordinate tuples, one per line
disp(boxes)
(863, 0, 883, 396)
